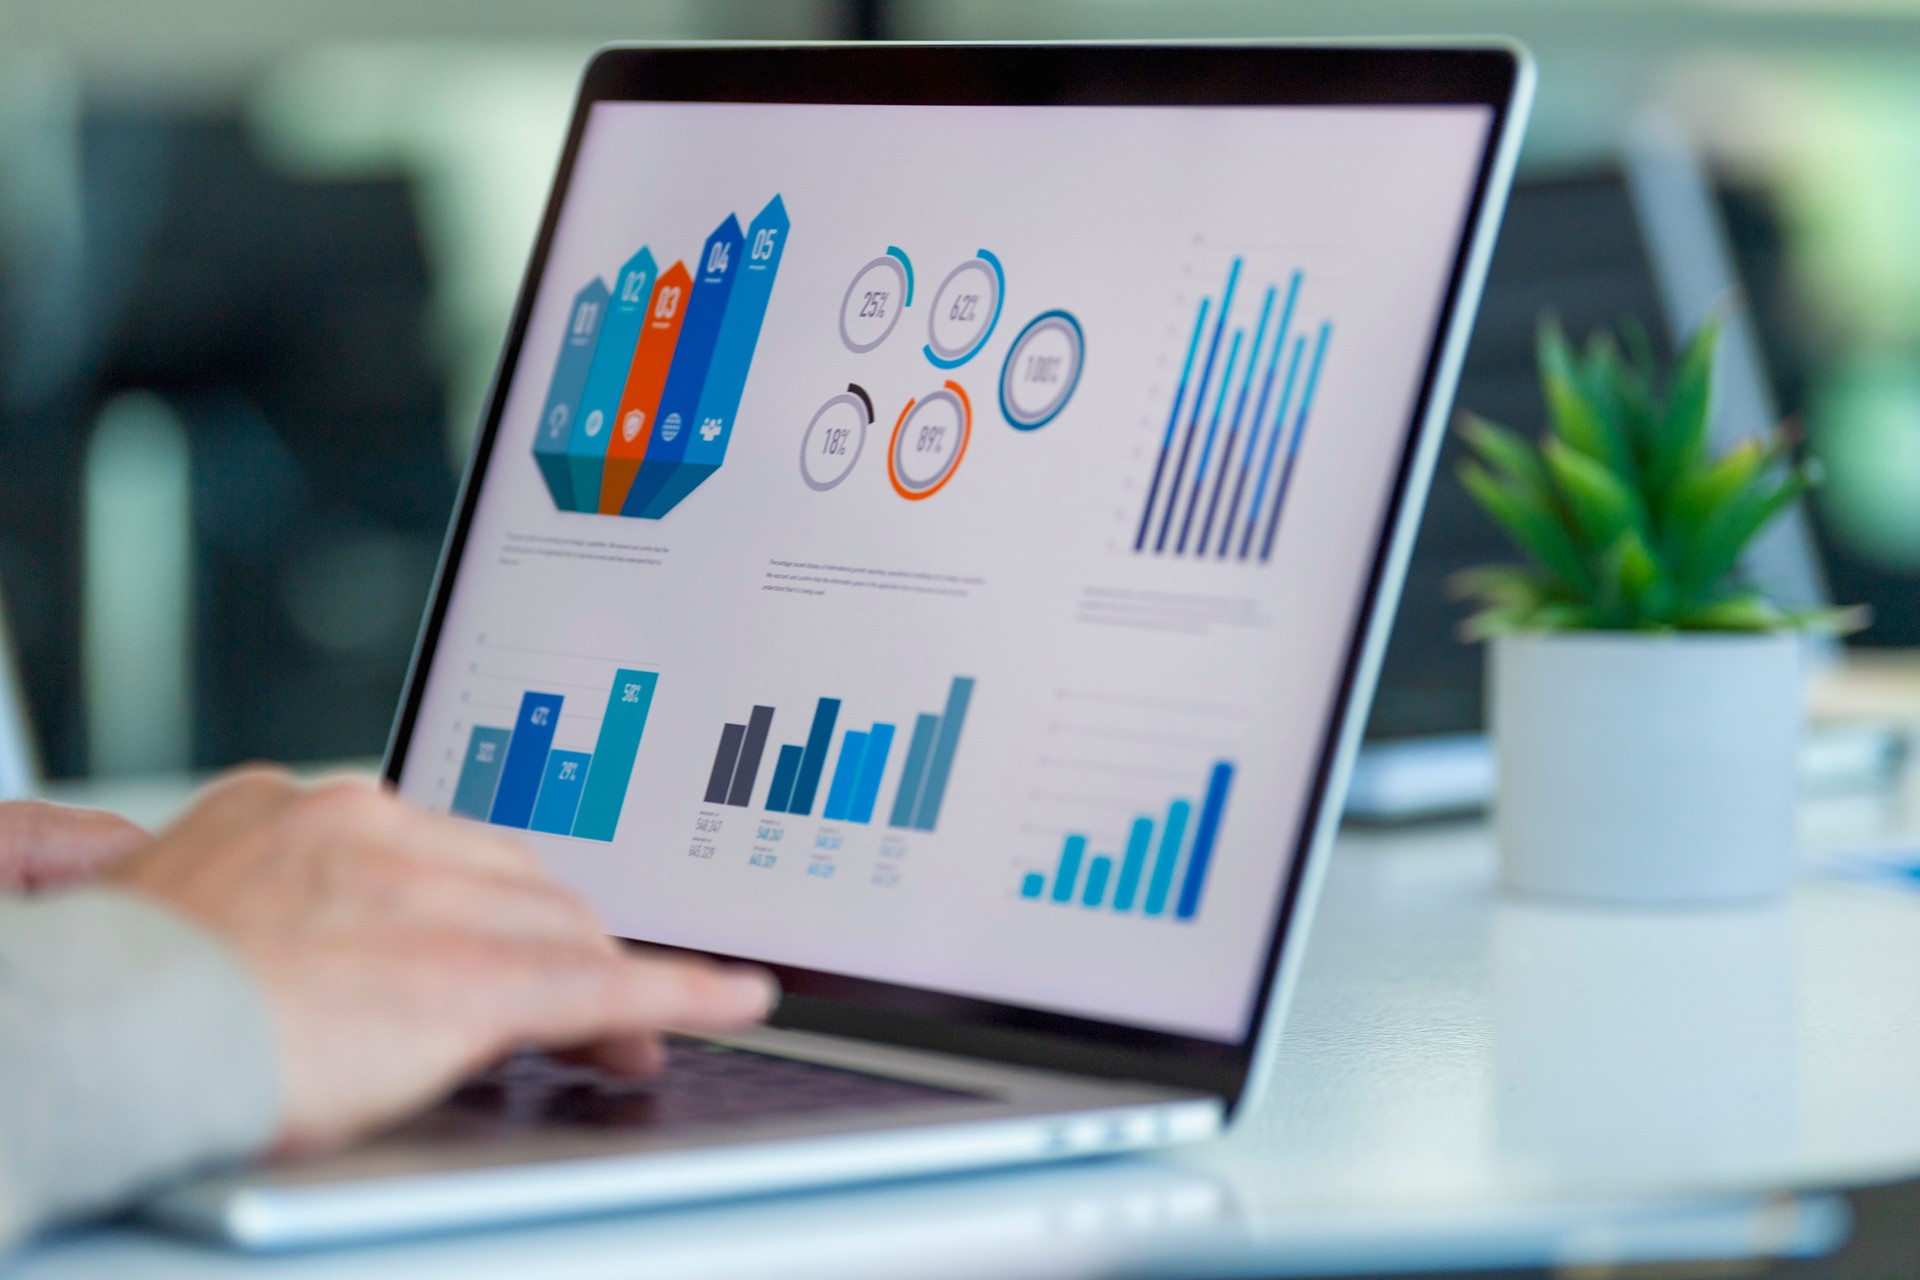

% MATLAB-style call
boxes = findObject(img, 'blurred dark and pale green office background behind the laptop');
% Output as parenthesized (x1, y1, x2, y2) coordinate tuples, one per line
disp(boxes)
(0, 0, 1920, 777)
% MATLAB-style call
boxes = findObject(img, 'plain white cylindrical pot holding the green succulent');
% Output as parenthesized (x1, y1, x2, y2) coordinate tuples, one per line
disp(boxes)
(1488, 631, 1801, 906)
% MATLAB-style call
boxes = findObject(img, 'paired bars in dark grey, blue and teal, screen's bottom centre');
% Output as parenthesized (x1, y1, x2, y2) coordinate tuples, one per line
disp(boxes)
(703, 676, 973, 831)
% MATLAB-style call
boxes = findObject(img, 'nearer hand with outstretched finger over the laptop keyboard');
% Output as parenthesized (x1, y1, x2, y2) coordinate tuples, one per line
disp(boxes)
(108, 770, 776, 1151)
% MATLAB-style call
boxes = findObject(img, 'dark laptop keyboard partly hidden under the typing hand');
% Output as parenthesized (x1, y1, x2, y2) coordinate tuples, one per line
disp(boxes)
(409, 1036, 981, 1136)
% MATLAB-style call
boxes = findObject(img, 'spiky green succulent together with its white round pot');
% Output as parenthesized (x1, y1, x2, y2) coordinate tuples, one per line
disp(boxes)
(1455, 319, 1855, 904)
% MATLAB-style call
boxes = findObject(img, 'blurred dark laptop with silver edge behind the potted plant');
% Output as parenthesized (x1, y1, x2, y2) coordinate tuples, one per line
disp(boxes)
(1348, 138, 1826, 819)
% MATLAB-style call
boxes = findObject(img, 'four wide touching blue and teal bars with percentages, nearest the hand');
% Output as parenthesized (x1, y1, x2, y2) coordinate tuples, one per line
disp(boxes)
(451, 668, 659, 841)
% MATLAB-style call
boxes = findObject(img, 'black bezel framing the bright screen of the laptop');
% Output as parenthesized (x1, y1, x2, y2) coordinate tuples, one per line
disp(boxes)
(382, 44, 1521, 1107)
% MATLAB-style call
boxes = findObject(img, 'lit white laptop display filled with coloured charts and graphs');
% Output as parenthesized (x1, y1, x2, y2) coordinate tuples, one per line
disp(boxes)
(399, 102, 1494, 1042)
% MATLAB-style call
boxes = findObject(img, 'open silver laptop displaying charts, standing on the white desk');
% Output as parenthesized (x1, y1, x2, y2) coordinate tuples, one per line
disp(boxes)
(152, 44, 1532, 1247)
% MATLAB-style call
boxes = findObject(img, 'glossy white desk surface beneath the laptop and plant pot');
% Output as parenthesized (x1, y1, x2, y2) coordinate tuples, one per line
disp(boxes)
(15, 779, 1920, 1280)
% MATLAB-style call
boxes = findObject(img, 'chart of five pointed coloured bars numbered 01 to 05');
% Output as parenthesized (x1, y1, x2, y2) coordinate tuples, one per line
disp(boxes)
(534, 196, 789, 520)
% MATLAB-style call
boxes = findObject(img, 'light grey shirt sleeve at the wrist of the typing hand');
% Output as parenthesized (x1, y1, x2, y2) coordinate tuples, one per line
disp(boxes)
(0, 887, 280, 1251)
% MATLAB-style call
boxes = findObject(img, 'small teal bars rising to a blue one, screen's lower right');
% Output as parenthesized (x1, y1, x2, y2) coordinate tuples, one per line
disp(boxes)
(1020, 760, 1233, 919)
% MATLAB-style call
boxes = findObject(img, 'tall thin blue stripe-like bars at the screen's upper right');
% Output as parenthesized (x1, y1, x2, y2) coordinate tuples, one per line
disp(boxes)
(1133, 255, 1332, 562)
